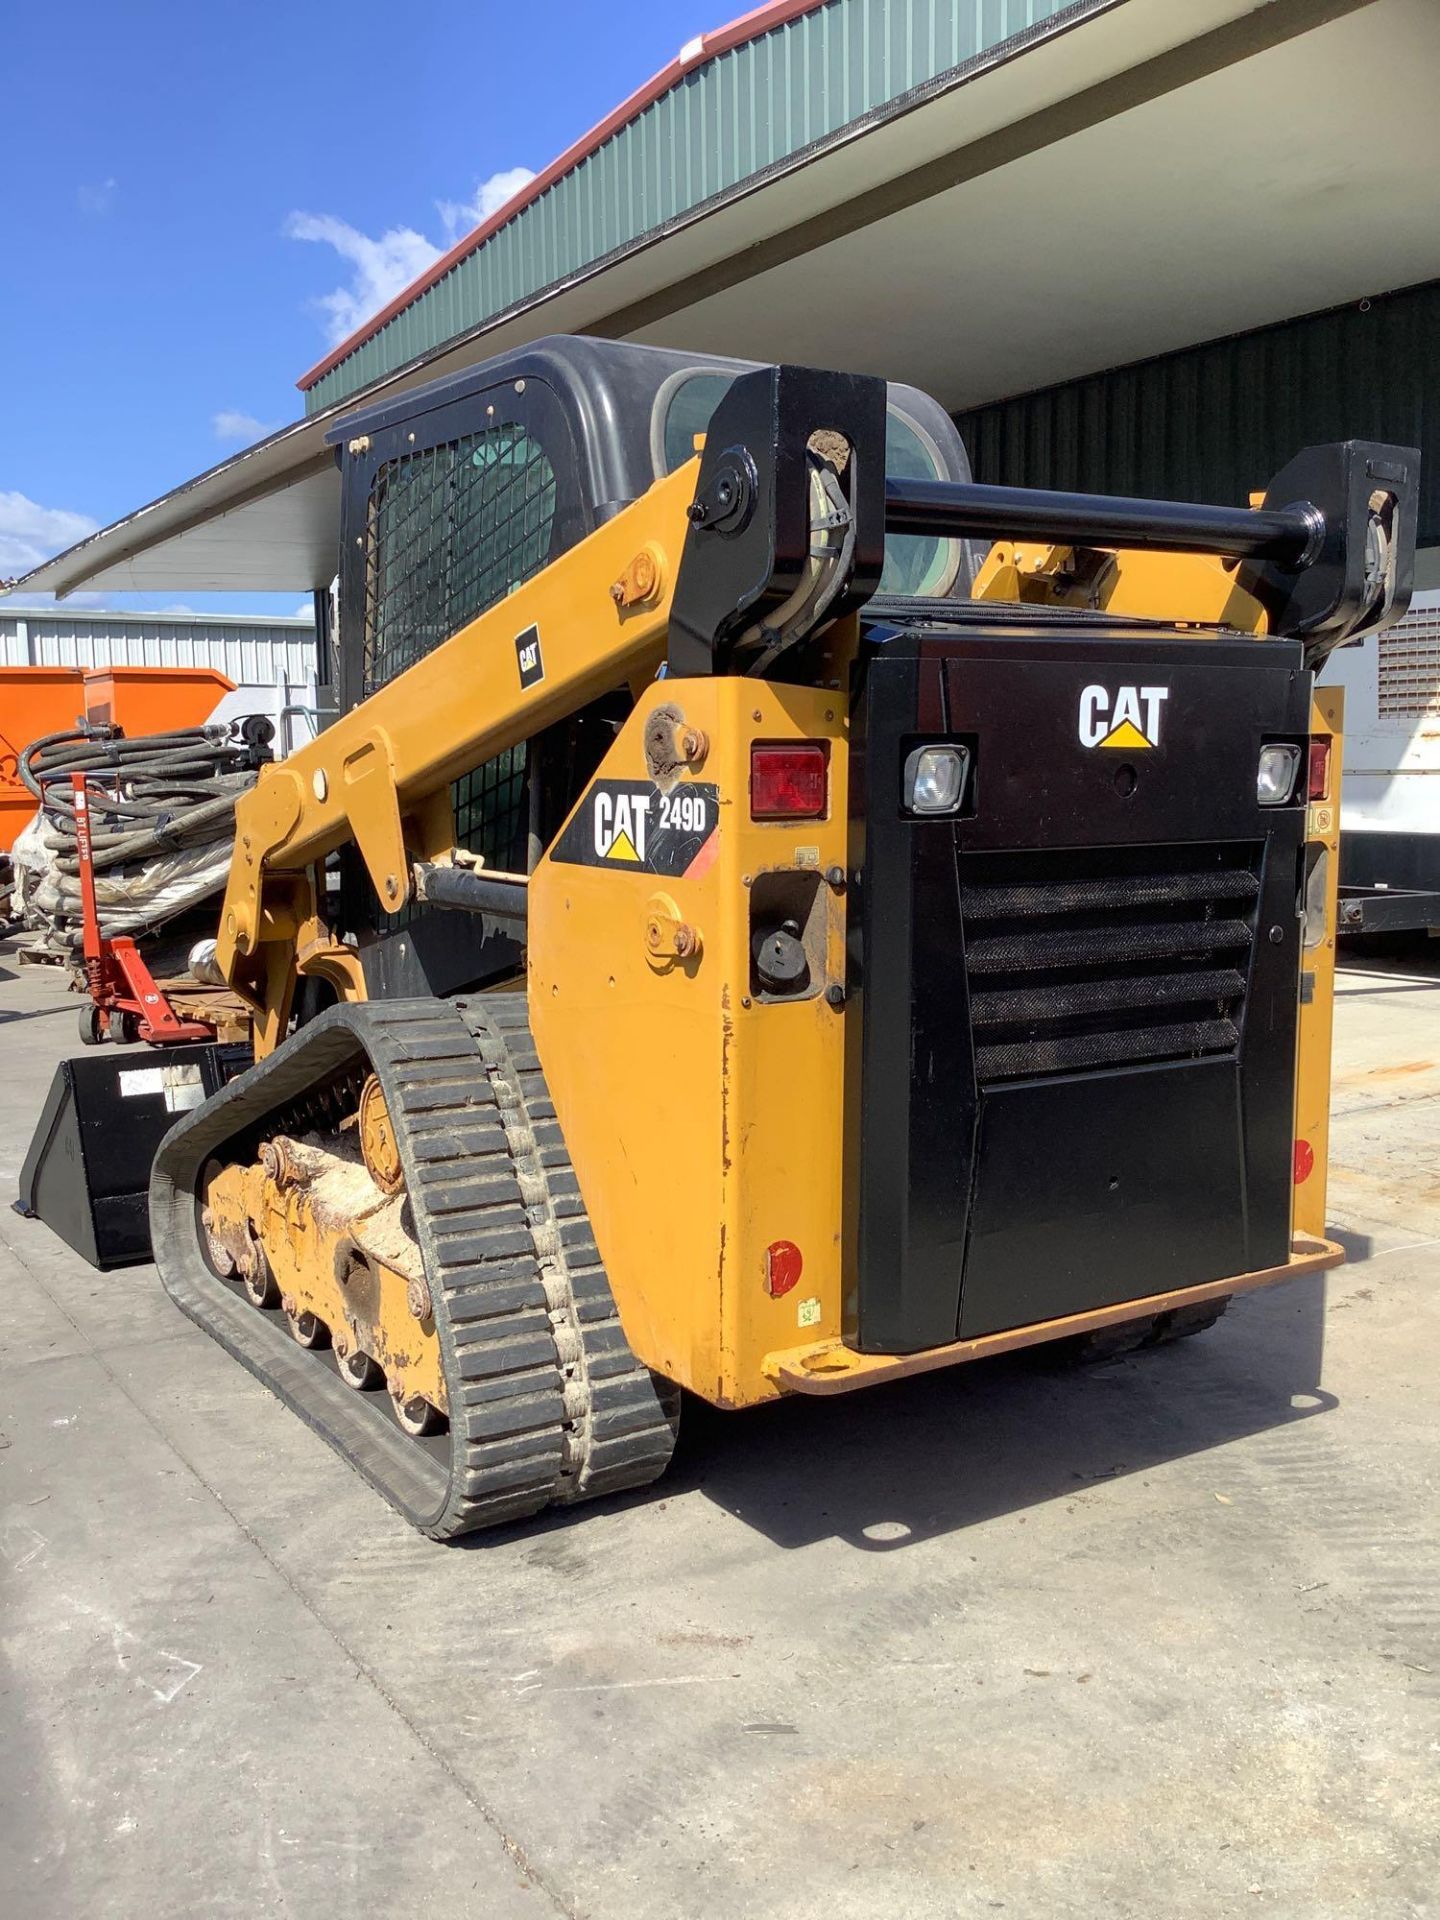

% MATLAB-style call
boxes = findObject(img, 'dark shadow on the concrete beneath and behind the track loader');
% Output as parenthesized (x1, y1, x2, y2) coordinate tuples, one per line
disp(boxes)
(487, 1275, 1334, 1553)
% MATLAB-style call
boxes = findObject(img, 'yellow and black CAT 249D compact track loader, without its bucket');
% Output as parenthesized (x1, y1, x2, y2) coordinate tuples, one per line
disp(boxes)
(150, 340, 1419, 1538)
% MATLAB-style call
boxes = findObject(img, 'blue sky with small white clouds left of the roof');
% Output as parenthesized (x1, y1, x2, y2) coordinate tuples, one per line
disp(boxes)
(0, 0, 710, 612)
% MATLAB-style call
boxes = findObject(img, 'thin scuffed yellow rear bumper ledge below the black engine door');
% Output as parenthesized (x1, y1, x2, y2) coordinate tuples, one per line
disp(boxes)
(764, 1235, 1346, 1394)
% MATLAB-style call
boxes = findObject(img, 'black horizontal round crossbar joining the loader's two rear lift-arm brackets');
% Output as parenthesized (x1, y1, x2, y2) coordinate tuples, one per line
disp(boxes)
(885, 480, 1325, 568)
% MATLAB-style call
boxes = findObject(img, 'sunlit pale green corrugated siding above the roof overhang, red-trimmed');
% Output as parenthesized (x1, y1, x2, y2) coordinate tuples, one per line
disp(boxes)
(305, 0, 1091, 413)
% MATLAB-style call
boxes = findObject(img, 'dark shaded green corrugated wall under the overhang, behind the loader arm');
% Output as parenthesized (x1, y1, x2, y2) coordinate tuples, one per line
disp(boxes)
(956, 280, 1440, 545)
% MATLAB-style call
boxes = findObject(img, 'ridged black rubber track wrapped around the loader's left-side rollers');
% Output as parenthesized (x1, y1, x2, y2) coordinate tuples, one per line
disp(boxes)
(150, 995, 674, 1540)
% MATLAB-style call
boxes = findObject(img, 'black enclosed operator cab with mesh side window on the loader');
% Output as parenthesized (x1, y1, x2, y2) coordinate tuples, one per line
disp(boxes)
(330, 338, 979, 993)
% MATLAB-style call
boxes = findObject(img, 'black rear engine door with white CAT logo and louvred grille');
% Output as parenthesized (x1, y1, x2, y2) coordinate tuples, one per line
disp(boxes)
(847, 611, 1311, 1352)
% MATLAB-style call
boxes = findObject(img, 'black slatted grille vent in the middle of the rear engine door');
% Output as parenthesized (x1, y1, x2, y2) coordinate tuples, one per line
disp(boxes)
(960, 845, 1261, 1083)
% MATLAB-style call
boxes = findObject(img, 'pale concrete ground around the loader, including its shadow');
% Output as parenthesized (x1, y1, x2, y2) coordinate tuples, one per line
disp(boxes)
(0, 948, 1440, 1920)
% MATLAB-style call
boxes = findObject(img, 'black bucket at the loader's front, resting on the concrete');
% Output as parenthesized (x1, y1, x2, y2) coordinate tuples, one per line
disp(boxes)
(15, 1041, 250, 1271)
